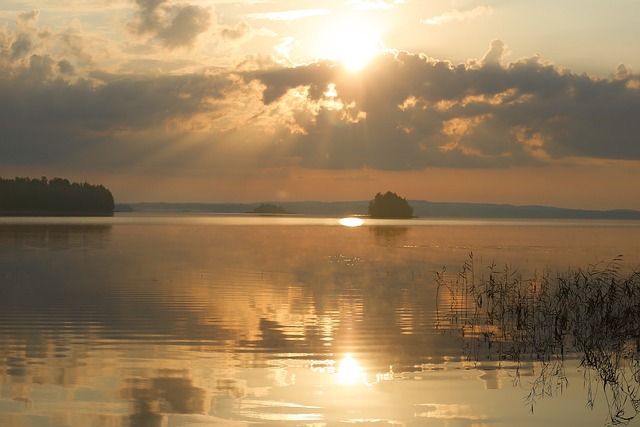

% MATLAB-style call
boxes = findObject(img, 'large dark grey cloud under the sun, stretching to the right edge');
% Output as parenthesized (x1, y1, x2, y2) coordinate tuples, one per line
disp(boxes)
(246, 40, 640, 170)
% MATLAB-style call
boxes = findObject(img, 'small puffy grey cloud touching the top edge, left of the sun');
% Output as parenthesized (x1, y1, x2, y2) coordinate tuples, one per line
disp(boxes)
(130, 0, 213, 49)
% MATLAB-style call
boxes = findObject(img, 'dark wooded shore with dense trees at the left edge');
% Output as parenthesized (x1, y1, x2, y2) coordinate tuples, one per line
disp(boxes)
(0, 177, 114, 215)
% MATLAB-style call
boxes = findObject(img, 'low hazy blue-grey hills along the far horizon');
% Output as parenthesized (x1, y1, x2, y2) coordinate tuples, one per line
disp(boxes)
(115, 200, 640, 219)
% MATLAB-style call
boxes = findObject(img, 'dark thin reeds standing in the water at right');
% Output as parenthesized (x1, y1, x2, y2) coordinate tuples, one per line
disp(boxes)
(436, 254, 640, 424)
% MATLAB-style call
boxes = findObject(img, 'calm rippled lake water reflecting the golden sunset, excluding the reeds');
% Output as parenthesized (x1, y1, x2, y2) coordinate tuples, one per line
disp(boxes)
(0, 214, 640, 427)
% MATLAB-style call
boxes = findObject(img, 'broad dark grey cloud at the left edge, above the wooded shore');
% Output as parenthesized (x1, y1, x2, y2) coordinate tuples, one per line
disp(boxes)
(0, 64, 230, 166)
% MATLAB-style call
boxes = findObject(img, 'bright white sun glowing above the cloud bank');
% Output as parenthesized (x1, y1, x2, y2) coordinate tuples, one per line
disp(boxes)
(316, 18, 382, 72)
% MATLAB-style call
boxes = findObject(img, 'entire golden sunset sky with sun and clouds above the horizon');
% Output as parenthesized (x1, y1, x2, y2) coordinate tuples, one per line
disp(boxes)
(0, 0, 640, 209)
